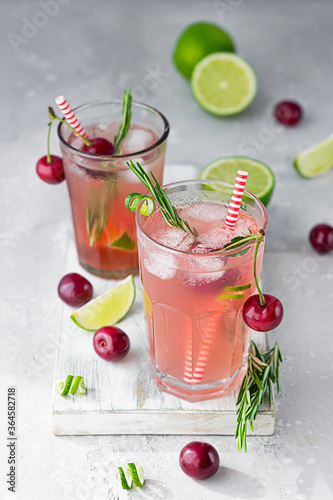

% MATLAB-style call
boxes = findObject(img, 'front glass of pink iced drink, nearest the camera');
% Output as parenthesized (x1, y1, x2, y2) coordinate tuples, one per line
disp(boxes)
(137, 181, 267, 401)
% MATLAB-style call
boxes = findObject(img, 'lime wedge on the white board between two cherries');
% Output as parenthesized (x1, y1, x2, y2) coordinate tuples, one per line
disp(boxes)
(71, 275, 135, 331)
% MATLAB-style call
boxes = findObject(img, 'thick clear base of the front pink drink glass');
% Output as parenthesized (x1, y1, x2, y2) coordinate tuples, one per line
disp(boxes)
(149, 360, 247, 403)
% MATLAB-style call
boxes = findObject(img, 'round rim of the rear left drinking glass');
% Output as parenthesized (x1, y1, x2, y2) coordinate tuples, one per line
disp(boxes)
(57, 99, 170, 161)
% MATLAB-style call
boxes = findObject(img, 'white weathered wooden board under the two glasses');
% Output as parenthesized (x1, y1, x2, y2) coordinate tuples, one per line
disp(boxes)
(52, 165, 275, 435)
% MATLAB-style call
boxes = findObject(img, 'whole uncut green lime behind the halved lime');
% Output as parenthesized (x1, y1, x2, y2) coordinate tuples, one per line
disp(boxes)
(173, 22, 235, 78)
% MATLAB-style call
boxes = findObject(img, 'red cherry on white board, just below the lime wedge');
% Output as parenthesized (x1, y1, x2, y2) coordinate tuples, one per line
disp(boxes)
(93, 326, 130, 361)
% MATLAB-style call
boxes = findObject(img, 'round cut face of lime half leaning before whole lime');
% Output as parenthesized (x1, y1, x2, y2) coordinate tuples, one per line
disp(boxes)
(191, 52, 257, 116)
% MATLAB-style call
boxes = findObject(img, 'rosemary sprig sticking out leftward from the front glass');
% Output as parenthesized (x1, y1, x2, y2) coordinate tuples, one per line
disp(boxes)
(126, 160, 198, 237)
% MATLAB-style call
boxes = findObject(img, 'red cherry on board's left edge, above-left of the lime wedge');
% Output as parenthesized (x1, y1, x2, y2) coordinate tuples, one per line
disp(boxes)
(58, 273, 93, 307)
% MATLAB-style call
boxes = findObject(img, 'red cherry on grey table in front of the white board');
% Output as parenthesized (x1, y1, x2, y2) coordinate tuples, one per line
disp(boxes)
(179, 441, 220, 479)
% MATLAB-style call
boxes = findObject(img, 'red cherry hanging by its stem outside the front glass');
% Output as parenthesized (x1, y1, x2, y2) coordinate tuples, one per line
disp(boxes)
(242, 294, 283, 332)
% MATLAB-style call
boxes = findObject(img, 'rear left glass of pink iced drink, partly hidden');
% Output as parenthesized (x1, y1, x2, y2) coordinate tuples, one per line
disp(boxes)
(58, 101, 169, 278)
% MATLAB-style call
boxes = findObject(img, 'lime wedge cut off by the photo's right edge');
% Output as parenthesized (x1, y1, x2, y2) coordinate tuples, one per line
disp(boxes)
(294, 135, 333, 178)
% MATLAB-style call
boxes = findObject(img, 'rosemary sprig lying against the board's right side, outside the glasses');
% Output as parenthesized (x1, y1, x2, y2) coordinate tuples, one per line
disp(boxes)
(235, 340, 282, 453)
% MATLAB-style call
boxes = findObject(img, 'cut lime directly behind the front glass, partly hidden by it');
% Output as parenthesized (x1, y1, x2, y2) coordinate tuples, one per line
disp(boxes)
(199, 156, 275, 205)
